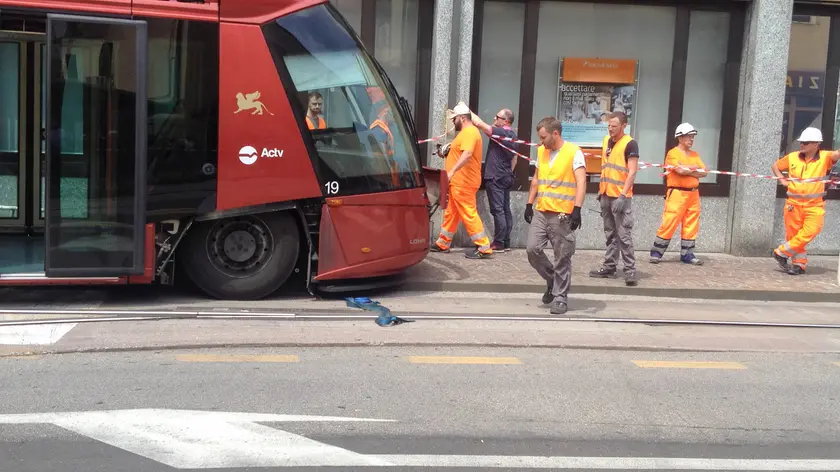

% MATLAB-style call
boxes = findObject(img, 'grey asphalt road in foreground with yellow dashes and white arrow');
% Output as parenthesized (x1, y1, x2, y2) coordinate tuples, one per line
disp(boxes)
(0, 347, 840, 472)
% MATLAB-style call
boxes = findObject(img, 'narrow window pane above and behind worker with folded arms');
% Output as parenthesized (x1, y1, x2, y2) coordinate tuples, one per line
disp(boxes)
(684, 11, 731, 183)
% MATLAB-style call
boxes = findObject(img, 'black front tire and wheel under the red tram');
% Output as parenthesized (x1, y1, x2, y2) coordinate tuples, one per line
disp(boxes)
(178, 212, 300, 300)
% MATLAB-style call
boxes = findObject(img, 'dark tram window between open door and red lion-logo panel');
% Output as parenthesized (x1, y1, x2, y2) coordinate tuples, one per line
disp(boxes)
(146, 18, 219, 214)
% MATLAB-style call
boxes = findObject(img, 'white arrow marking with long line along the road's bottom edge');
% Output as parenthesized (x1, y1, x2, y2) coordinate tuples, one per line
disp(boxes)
(0, 409, 840, 471)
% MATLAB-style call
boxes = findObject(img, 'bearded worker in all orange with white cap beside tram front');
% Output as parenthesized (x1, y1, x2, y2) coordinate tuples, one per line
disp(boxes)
(431, 102, 493, 259)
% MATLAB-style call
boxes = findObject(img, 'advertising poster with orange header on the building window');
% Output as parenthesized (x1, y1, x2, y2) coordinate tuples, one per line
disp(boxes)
(557, 57, 638, 148)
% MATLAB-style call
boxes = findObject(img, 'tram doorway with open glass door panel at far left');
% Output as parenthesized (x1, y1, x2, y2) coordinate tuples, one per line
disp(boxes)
(0, 10, 147, 278)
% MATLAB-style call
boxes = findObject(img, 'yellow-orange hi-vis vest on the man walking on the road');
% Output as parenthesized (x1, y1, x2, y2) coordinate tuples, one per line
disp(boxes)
(534, 141, 580, 215)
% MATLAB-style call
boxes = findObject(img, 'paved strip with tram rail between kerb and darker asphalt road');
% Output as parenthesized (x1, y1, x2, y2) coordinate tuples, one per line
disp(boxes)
(0, 288, 840, 355)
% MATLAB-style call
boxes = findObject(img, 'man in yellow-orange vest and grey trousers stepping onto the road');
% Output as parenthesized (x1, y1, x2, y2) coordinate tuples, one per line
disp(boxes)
(525, 117, 586, 315)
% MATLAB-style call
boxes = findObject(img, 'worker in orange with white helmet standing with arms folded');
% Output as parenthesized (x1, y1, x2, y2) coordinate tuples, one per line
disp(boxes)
(650, 123, 708, 265)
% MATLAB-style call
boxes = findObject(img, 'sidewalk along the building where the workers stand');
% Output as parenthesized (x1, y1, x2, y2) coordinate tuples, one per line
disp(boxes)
(402, 248, 840, 302)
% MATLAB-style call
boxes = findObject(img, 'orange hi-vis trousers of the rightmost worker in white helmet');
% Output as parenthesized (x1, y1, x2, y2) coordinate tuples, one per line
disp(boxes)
(776, 200, 825, 270)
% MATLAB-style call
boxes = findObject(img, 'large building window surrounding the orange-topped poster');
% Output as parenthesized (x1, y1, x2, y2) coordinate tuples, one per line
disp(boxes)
(532, 1, 676, 184)
